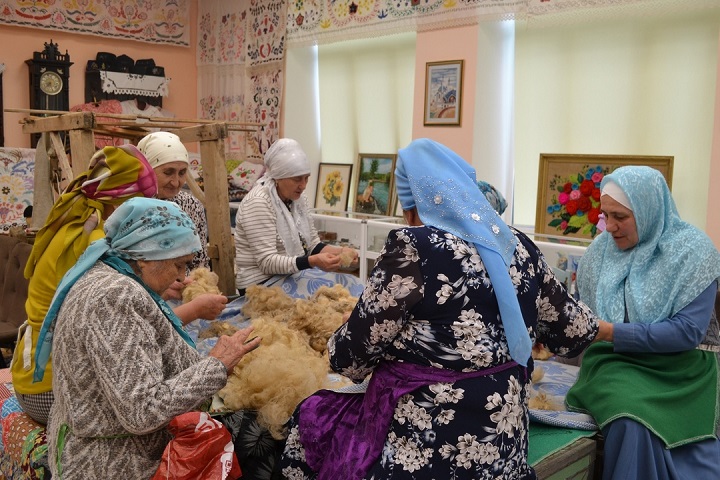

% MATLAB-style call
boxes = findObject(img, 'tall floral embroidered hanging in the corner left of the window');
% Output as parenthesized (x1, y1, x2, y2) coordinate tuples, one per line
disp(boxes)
(197, 0, 287, 163)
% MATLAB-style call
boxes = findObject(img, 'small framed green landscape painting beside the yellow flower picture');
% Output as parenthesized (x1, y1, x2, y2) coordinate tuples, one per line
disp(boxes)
(351, 153, 397, 216)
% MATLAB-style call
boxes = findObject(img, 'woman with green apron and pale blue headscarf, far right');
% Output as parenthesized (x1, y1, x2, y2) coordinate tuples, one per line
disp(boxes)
(567, 166, 720, 479)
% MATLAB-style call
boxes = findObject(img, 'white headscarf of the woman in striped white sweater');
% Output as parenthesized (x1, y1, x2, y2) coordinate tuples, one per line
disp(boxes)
(259, 138, 312, 256)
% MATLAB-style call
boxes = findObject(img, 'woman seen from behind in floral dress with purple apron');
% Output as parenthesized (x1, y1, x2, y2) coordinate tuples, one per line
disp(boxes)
(281, 139, 604, 480)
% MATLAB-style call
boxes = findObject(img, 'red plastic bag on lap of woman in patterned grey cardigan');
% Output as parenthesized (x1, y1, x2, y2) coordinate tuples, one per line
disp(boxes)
(151, 412, 242, 480)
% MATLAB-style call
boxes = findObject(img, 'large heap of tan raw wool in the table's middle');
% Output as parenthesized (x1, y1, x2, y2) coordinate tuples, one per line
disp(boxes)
(214, 285, 357, 439)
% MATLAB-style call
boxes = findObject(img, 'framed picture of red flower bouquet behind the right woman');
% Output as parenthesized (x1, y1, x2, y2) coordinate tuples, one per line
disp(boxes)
(535, 153, 674, 240)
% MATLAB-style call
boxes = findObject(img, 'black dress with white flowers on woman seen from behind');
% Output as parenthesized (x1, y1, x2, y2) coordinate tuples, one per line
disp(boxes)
(281, 226, 598, 480)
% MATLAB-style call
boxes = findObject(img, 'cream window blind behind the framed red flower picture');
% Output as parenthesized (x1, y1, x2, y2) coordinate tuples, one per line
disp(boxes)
(514, 9, 720, 228)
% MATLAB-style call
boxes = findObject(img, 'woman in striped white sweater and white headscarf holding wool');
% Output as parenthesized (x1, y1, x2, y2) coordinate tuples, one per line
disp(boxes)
(235, 138, 357, 293)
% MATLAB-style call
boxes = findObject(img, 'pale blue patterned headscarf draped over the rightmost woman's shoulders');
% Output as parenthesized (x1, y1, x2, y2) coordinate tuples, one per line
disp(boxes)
(577, 166, 720, 323)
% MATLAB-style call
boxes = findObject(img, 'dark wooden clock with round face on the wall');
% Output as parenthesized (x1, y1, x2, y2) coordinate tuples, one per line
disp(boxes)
(25, 40, 72, 148)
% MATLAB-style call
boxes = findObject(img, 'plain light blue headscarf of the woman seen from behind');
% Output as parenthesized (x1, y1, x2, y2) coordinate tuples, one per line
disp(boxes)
(395, 138, 532, 366)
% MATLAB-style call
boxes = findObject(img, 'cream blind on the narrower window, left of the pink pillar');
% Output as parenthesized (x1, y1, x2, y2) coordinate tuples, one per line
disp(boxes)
(284, 33, 415, 206)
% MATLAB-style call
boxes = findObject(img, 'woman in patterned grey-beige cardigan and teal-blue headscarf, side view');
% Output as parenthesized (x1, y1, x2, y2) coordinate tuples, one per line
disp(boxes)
(40, 198, 260, 480)
